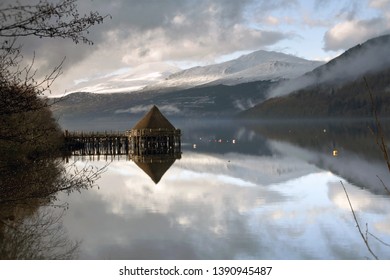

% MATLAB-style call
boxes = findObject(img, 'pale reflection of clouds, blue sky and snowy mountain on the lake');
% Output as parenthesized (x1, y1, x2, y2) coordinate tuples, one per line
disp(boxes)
(57, 152, 390, 259)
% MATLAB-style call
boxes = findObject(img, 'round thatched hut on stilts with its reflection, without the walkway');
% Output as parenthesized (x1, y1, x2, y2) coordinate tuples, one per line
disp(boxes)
(129, 106, 181, 184)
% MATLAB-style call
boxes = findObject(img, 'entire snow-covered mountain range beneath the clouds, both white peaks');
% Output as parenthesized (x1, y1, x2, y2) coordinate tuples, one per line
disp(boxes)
(71, 51, 323, 93)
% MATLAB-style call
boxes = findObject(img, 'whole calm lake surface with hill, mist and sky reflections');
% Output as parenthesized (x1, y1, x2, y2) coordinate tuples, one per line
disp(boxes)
(58, 120, 390, 260)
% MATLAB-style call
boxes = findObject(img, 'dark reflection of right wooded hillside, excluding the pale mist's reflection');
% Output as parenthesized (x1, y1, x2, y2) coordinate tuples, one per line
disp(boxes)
(246, 120, 390, 160)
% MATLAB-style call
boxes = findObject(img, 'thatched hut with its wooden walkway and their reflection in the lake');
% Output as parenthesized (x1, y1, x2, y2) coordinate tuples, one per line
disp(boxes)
(65, 106, 181, 184)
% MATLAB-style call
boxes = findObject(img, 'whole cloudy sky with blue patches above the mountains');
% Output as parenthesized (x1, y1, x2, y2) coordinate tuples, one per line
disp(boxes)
(0, 0, 390, 95)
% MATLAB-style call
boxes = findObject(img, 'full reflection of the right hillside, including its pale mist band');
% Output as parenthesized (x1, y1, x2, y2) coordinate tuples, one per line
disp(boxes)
(250, 122, 390, 193)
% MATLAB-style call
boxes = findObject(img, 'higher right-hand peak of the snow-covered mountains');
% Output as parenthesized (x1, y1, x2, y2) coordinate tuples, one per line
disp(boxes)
(154, 50, 323, 87)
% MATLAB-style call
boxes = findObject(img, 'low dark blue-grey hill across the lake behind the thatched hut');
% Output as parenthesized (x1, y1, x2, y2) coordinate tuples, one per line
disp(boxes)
(51, 81, 273, 129)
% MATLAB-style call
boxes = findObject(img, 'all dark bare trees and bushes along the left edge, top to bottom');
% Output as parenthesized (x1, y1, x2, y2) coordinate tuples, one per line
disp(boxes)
(0, 0, 106, 259)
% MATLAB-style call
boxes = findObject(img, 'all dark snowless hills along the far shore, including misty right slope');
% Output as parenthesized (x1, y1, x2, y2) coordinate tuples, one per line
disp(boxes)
(53, 35, 390, 127)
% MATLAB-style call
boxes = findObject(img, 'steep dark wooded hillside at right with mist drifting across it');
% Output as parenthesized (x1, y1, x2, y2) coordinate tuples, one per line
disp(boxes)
(240, 35, 390, 119)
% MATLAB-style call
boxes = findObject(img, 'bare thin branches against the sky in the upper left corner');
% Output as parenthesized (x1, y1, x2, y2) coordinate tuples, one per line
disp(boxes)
(0, 0, 108, 99)
